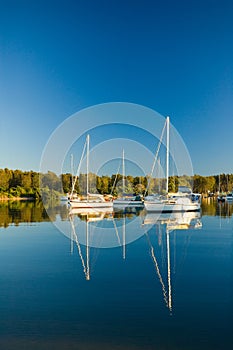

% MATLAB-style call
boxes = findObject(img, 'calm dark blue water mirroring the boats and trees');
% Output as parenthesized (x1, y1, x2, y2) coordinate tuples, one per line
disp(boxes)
(0, 201, 233, 350)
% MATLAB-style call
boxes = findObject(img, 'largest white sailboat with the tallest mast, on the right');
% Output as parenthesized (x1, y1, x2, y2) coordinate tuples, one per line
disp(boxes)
(144, 117, 201, 213)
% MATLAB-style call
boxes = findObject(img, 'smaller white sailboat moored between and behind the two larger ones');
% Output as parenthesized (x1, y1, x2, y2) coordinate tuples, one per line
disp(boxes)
(113, 150, 143, 209)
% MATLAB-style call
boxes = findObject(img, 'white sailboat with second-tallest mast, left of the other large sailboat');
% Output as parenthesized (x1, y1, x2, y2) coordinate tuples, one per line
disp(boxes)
(69, 135, 113, 210)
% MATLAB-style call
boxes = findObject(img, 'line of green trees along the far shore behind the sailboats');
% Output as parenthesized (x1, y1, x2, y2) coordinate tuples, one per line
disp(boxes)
(0, 168, 233, 199)
